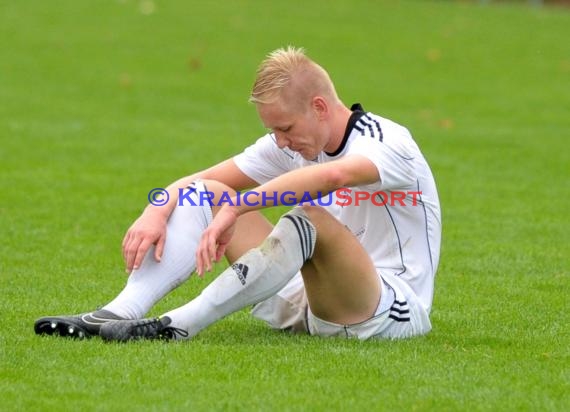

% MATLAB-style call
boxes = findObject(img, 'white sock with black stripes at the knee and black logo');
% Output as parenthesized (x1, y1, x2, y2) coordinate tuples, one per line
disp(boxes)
(164, 208, 316, 338)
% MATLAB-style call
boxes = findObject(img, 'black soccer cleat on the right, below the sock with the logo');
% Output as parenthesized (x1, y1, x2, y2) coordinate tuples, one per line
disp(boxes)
(99, 316, 188, 342)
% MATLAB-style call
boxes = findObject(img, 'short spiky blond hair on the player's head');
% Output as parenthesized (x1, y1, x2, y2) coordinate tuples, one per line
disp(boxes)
(249, 46, 338, 109)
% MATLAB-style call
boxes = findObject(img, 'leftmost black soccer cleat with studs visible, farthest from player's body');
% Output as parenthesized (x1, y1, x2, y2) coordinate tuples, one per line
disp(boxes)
(34, 309, 123, 339)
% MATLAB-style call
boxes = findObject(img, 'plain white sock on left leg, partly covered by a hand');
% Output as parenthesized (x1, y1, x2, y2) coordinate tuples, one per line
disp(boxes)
(103, 183, 212, 319)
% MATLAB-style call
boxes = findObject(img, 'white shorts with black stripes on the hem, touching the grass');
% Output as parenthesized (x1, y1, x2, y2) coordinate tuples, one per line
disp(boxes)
(251, 273, 431, 340)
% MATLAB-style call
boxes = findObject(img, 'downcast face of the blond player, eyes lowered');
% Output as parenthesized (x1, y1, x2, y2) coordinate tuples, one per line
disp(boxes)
(257, 100, 327, 160)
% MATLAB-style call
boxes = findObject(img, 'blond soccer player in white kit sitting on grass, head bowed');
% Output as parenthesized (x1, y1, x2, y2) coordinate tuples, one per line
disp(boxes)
(35, 47, 441, 341)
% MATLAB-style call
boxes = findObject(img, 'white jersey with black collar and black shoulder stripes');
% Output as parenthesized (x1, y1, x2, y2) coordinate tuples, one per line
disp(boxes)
(234, 104, 441, 313)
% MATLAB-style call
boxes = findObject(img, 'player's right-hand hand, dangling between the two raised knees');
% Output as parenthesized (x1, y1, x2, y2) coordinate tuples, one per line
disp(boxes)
(196, 205, 239, 276)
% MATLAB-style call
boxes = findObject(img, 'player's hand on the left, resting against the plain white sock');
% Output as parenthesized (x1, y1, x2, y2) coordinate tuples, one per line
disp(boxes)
(122, 209, 168, 273)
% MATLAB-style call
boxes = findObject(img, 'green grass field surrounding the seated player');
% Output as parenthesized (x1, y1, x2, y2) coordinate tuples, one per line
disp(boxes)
(0, 0, 570, 411)
